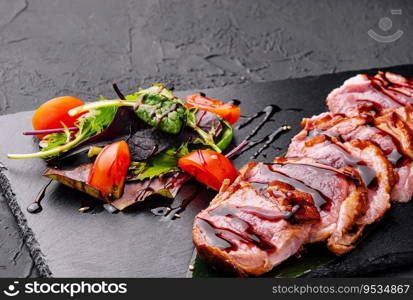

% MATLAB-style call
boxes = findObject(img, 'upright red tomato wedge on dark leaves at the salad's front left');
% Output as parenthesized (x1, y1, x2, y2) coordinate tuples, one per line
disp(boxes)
(87, 141, 131, 199)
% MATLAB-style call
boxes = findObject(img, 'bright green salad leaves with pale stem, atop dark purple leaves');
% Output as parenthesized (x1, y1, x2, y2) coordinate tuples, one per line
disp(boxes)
(9, 84, 233, 180)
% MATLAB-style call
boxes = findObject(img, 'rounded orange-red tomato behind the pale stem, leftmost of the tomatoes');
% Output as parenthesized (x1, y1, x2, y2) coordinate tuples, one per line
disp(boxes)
(32, 96, 84, 139)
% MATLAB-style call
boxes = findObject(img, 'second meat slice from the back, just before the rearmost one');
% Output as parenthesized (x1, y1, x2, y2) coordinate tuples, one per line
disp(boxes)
(299, 112, 413, 202)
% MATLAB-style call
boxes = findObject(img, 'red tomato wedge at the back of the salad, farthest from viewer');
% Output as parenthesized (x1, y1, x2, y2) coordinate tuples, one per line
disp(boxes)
(185, 94, 241, 125)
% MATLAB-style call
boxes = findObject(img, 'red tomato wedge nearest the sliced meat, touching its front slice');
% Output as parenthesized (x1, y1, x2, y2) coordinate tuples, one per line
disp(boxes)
(178, 150, 238, 191)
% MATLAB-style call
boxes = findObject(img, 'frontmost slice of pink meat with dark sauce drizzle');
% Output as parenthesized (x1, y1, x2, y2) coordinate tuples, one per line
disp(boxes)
(192, 164, 311, 276)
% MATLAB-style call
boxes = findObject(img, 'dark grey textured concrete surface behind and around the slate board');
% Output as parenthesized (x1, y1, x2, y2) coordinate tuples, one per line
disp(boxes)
(0, 0, 413, 277)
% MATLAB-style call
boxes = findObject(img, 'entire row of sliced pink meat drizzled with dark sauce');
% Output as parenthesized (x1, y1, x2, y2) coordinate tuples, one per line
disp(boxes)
(193, 72, 413, 276)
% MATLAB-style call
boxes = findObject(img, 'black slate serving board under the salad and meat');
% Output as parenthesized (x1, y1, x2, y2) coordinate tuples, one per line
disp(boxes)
(0, 66, 413, 277)
